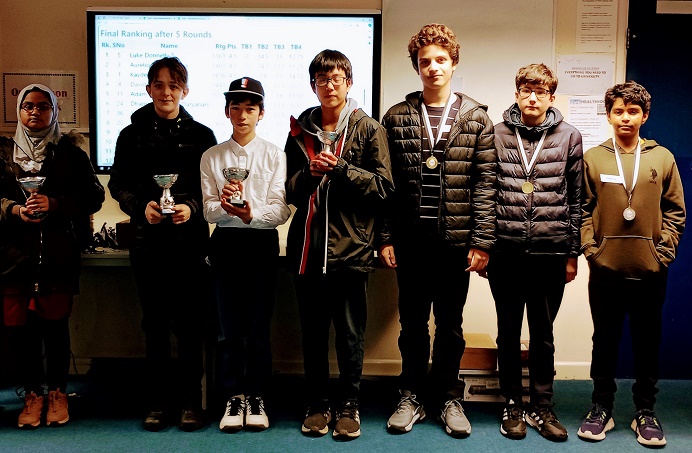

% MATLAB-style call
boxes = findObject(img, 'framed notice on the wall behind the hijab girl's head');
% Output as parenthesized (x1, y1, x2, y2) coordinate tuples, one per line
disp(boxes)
(2, 71, 79, 127)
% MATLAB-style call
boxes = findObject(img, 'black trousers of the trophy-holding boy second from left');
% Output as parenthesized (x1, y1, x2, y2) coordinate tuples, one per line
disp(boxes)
(130, 247, 209, 409)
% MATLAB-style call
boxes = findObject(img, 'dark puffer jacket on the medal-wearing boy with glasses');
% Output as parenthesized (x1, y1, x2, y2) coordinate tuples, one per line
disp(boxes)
(495, 104, 583, 257)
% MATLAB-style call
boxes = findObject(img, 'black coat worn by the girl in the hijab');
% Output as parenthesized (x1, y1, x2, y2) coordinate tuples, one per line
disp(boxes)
(0, 133, 105, 294)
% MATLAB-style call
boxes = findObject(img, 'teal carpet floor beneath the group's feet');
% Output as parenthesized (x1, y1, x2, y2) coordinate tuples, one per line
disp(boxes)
(0, 376, 692, 453)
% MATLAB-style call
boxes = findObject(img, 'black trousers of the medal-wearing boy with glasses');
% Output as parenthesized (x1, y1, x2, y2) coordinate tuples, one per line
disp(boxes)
(488, 253, 567, 406)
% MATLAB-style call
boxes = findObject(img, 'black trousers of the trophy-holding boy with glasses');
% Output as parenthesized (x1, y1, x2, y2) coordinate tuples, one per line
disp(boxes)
(295, 270, 369, 406)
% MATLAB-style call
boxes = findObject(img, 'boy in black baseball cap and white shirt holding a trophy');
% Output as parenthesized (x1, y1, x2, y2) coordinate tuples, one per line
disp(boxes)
(200, 77, 291, 432)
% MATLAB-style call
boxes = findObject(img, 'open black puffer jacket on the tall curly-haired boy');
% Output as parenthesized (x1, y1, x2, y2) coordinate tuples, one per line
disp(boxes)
(382, 91, 497, 251)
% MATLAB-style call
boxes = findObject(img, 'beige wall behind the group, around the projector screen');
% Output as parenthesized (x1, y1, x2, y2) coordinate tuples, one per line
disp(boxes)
(0, 0, 627, 379)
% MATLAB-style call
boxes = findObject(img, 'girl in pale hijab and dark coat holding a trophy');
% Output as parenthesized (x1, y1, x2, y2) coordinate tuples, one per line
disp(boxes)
(0, 83, 105, 428)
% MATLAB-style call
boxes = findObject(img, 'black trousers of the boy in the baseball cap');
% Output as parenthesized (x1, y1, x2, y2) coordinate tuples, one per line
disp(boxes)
(209, 227, 279, 400)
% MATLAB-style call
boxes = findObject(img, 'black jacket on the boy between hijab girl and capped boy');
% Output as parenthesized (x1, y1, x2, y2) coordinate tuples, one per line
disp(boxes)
(108, 103, 216, 256)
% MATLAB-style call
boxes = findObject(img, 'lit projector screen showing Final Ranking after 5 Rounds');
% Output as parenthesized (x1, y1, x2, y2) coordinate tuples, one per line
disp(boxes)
(87, 9, 382, 173)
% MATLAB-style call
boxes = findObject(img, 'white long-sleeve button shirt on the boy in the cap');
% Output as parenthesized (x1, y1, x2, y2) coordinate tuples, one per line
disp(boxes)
(200, 133, 291, 229)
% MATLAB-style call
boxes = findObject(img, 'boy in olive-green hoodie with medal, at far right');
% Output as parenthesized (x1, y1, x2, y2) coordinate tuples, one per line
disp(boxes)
(577, 81, 685, 446)
